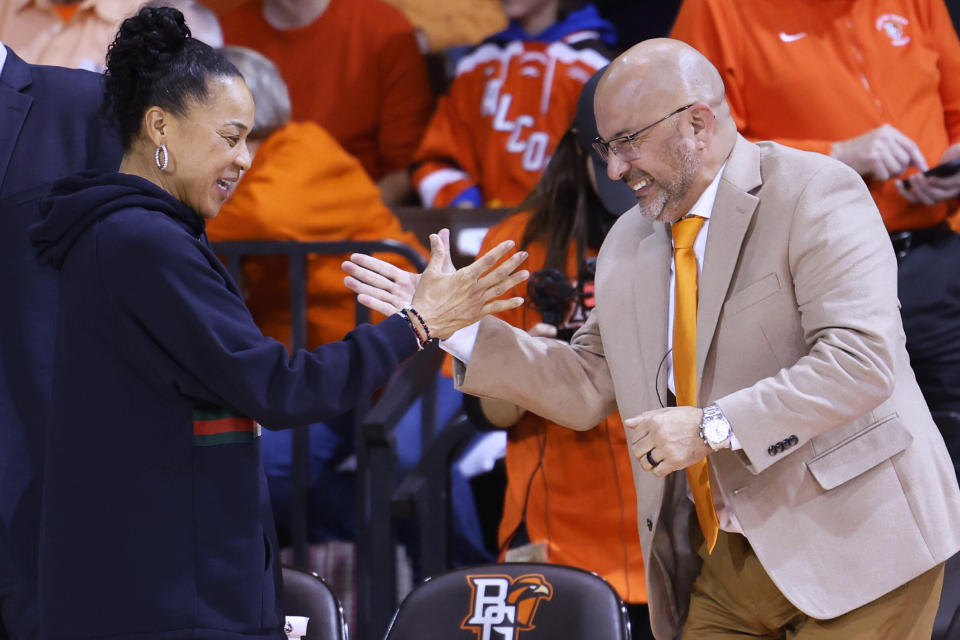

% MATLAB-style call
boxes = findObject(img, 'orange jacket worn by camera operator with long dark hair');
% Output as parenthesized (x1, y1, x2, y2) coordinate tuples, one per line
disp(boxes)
(481, 213, 647, 603)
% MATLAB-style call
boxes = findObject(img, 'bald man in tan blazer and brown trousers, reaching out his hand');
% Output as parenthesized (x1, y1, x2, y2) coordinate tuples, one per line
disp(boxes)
(348, 40, 960, 640)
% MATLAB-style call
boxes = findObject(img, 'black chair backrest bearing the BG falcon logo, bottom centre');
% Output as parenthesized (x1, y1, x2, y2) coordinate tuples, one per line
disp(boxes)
(378, 563, 630, 640)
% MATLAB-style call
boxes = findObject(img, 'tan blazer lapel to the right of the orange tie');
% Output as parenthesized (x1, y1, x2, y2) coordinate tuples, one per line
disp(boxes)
(697, 136, 762, 390)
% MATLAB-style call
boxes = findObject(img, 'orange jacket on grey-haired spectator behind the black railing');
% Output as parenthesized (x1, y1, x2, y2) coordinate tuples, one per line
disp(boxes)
(207, 122, 425, 348)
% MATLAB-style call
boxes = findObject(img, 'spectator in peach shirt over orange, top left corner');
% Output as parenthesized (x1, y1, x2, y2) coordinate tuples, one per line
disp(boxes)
(0, 0, 144, 71)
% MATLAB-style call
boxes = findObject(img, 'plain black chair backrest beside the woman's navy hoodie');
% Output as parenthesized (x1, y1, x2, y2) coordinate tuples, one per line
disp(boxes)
(283, 567, 347, 640)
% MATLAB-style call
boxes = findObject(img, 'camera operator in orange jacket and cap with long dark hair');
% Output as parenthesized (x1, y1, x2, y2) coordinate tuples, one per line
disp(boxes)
(466, 67, 653, 640)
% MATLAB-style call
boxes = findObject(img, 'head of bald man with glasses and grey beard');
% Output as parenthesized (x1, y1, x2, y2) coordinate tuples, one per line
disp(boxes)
(594, 38, 737, 222)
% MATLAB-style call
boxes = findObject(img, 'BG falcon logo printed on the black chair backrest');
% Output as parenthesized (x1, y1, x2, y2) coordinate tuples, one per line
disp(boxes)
(460, 573, 553, 640)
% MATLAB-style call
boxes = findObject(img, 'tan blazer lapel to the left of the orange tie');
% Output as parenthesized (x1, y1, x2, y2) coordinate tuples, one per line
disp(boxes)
(632, 223, 673, 405)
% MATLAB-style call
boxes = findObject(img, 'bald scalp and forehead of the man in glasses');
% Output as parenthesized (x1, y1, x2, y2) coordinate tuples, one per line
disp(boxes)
(594, 38, 732, 139)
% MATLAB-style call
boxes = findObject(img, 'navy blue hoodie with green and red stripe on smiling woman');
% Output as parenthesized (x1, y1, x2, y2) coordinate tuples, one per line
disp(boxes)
(31, 172, 416, 640)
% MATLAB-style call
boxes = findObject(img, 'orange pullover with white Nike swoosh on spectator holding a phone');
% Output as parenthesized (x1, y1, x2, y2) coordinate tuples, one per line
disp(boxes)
(672, 0, 960, 231)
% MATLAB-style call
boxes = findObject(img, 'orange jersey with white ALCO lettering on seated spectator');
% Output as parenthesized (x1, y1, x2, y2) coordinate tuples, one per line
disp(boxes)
(413, 40, 607, 207)
